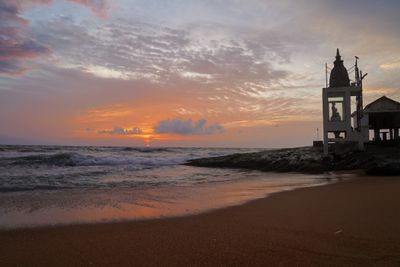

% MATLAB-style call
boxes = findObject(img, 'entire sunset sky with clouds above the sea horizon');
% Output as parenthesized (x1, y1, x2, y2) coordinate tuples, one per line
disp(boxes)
(0, 0, 400, 148)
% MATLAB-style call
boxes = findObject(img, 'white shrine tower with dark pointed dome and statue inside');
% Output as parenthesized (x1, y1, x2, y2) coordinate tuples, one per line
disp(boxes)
(322, 49, 368, 155)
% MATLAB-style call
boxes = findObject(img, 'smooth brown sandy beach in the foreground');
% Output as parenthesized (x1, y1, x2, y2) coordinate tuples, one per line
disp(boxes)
(0, 177, 400, 266)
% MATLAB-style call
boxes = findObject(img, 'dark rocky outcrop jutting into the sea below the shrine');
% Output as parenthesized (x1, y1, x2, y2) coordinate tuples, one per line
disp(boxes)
(185, 143, 400, 176)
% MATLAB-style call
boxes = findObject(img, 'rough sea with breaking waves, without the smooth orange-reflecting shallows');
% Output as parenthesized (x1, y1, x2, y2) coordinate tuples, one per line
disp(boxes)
(0, 146, 262, 193)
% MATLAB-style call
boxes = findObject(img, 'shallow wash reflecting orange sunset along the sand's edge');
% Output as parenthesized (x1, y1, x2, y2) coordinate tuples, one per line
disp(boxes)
(0, 172, 350, 230)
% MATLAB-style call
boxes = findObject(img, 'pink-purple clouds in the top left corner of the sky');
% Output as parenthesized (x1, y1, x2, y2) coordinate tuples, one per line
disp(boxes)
(0, 0, 106, 75)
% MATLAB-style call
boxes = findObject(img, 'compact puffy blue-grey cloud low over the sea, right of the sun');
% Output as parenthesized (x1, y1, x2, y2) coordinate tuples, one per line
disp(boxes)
(154, 119, 224, 135)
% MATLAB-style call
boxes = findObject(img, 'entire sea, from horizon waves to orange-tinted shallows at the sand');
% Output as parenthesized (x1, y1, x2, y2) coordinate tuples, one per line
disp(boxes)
(0, 145, 341, 229)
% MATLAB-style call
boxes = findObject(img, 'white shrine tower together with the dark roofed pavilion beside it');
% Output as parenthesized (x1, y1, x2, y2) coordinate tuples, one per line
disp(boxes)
(322, 49, 400, 155)
